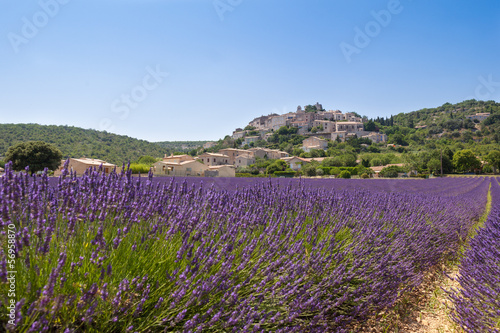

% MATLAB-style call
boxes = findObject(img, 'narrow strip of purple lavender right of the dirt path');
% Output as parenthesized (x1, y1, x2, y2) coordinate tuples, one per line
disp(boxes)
(452, 176, 500, 332)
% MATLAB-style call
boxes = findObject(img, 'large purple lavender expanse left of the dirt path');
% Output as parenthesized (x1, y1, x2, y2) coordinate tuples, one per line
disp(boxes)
(0, 168, 489, 332)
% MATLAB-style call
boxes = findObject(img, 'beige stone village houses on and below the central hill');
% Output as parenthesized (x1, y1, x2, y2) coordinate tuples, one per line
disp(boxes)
(49, 103, 387, 177)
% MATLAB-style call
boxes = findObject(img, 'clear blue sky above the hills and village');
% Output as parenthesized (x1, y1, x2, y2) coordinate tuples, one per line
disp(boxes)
(0, 0, 500, 141)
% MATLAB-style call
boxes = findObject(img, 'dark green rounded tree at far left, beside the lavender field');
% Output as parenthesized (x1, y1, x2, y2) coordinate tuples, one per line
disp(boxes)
(5, 141, 62, 172)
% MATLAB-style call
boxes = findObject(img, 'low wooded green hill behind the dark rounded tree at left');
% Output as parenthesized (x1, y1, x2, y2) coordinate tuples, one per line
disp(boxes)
(0, 124, 171, 165)
